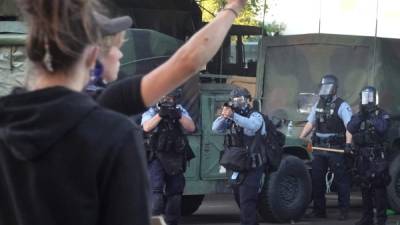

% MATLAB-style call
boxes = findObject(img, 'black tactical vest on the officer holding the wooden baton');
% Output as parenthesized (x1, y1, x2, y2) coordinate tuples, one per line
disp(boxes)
(315, 98, 346, 137)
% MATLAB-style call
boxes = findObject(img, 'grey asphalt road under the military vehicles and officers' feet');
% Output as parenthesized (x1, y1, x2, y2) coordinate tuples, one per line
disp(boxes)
(181, 194, 400, 225)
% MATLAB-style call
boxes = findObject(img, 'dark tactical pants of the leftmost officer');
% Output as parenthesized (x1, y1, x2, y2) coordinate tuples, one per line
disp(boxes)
(149, 159, 185, 225)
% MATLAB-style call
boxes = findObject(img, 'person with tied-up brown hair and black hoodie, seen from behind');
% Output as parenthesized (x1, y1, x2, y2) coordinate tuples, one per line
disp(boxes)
(0, 0, 150, 225)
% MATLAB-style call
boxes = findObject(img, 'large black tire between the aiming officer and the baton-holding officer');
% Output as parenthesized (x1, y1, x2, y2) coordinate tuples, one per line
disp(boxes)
(258, 155, 312, 222)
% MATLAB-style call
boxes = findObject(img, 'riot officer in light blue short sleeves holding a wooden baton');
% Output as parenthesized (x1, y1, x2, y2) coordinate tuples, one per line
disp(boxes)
(300, 74, 352, 220)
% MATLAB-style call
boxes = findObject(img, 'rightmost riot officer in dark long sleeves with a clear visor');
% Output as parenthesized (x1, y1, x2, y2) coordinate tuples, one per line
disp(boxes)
(346, 86, 390, 225)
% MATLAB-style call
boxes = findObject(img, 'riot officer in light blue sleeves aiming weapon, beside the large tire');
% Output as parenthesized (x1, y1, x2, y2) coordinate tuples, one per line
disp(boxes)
(212, 87, 266, 225)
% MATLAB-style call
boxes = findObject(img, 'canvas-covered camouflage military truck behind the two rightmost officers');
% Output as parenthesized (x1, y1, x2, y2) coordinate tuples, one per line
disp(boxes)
(257, 34, 400, 216)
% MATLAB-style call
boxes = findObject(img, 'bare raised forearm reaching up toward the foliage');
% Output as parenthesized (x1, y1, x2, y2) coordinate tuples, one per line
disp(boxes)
(141, 0, 246, 106)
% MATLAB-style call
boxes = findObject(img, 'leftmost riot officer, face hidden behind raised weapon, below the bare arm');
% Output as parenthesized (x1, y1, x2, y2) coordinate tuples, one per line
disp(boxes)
(142, 89, 195, 225)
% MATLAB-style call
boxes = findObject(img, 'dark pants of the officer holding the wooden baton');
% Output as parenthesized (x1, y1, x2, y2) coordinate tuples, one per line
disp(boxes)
(311, 151, 351, 215)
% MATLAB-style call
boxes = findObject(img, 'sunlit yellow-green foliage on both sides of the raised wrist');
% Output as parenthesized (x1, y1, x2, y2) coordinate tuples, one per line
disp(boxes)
(198, 0, 264, 26)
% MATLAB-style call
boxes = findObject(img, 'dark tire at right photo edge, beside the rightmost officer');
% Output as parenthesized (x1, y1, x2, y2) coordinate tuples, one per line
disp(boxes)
(386, 154, 400, 212)
